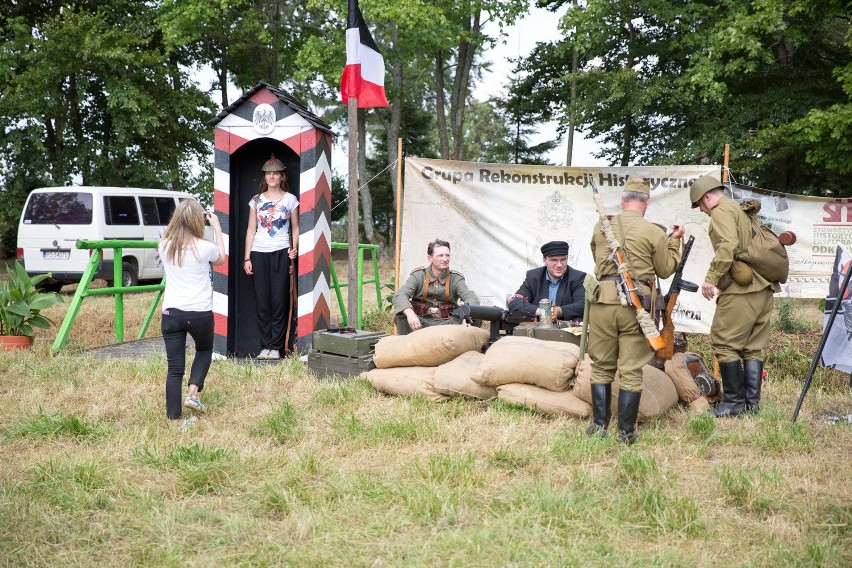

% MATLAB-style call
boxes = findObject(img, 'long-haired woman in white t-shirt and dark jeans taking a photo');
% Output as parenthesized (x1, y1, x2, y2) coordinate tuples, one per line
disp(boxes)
(157, 199, 225, 426)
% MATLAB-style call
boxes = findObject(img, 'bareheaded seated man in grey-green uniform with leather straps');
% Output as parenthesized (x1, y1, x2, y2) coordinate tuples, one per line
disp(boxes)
(393, 239, 479, 335)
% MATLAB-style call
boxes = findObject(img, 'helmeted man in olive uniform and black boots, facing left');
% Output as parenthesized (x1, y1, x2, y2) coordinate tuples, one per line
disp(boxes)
(689, 176, 781, 418)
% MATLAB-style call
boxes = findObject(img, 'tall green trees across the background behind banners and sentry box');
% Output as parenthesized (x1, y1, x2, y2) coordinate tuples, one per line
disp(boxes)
(0, 0, 852, 255)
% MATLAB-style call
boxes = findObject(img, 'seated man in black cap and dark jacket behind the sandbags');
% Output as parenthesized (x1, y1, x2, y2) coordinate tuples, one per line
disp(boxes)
(506, 241, 586, 321)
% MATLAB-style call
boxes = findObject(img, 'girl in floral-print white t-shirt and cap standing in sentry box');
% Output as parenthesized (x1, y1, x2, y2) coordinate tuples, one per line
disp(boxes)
(243, 154, 299, 359)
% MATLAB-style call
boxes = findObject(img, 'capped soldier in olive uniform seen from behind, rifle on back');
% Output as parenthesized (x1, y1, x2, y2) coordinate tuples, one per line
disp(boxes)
(587, 178, 683, 444)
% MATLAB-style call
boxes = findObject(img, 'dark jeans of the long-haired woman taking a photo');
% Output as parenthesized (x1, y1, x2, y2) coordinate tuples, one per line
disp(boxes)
(160, 308, 213, 419)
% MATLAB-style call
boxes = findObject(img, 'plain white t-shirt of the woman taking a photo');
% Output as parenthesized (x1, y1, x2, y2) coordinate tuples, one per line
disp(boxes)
(157, 239, 219, 312)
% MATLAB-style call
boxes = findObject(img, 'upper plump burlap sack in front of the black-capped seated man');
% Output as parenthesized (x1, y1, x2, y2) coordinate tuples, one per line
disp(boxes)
(471, 336, 580, 391)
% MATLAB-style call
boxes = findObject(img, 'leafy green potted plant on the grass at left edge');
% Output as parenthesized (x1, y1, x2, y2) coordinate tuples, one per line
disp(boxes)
(0, 261, 62, 351)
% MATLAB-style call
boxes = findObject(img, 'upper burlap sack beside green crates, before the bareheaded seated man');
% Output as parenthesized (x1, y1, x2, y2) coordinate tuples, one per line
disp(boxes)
(373, 325, 488, 369)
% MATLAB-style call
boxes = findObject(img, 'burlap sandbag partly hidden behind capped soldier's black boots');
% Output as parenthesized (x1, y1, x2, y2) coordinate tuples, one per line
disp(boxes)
(574, 356, 678, 422)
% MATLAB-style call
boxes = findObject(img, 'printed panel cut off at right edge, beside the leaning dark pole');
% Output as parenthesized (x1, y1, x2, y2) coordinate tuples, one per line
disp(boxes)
(822, 245, 852, 373)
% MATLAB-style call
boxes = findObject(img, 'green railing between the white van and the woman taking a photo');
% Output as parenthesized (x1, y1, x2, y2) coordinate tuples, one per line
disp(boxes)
(50, 240, 166, 353)
